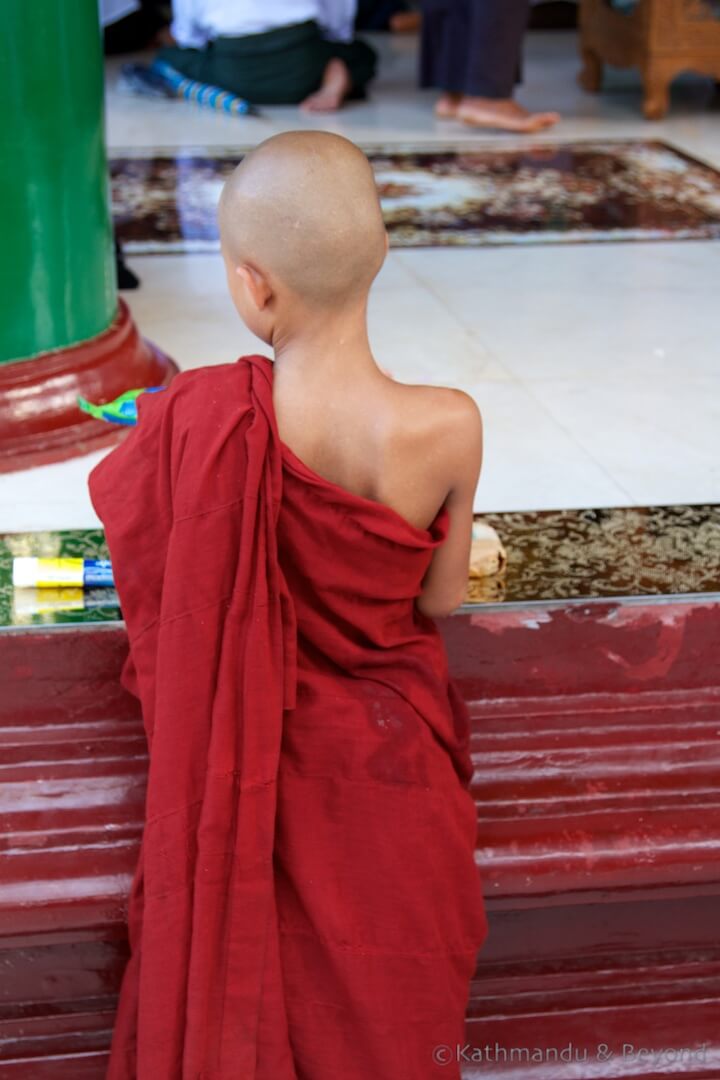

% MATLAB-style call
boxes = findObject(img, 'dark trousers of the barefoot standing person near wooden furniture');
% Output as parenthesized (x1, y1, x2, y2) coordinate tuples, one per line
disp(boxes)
(420, 0, 530, 98)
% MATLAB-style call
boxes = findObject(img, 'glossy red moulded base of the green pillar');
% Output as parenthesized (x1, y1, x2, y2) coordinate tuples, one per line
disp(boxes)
(0, 300, 178, 473)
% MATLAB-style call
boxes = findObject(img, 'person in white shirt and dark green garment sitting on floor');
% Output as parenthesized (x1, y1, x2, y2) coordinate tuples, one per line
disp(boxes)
(158, 0, 377, 112)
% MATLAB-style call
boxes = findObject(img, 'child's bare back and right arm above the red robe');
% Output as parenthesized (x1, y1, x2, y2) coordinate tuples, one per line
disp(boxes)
(273, 365, 481, 615)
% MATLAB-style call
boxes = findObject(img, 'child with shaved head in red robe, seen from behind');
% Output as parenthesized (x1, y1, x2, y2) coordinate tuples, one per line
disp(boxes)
(90, 132, 488, 1080)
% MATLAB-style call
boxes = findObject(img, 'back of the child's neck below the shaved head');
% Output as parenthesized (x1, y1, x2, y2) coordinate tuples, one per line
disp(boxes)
(272, 300, 379, 381)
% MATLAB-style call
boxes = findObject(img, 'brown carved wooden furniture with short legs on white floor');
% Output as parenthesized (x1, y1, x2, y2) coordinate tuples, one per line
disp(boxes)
(580, 0, 720, 120)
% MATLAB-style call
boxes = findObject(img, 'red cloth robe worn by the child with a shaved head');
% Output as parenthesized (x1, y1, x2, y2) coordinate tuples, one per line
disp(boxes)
(89, 356, 487, 1080)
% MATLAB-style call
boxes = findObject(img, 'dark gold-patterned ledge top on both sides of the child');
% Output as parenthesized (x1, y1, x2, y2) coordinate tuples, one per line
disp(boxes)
(0, 504, 720, 630)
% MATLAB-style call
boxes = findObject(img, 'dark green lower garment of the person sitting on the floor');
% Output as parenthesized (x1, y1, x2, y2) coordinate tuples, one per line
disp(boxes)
(158, 21, 377, 105)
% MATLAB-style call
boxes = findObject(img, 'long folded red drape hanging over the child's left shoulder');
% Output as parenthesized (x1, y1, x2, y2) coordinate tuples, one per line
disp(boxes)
(89, 364, 296, 1080)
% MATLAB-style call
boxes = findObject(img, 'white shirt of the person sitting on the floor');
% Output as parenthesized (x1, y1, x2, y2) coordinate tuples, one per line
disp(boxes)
(171, 0, 357, 49)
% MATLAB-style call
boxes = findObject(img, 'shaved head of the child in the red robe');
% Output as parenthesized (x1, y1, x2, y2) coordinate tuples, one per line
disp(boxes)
(218, 131, 385, 307)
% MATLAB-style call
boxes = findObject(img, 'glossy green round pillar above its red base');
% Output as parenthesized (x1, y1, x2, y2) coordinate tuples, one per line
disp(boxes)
(0, 0, 118, 364)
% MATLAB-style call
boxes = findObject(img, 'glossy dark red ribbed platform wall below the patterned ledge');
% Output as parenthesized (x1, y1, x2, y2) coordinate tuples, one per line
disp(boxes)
(0, 593, 720, 1080)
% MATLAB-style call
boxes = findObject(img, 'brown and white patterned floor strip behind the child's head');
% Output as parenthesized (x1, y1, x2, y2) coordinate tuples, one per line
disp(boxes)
(110, 140, 720, 255)
